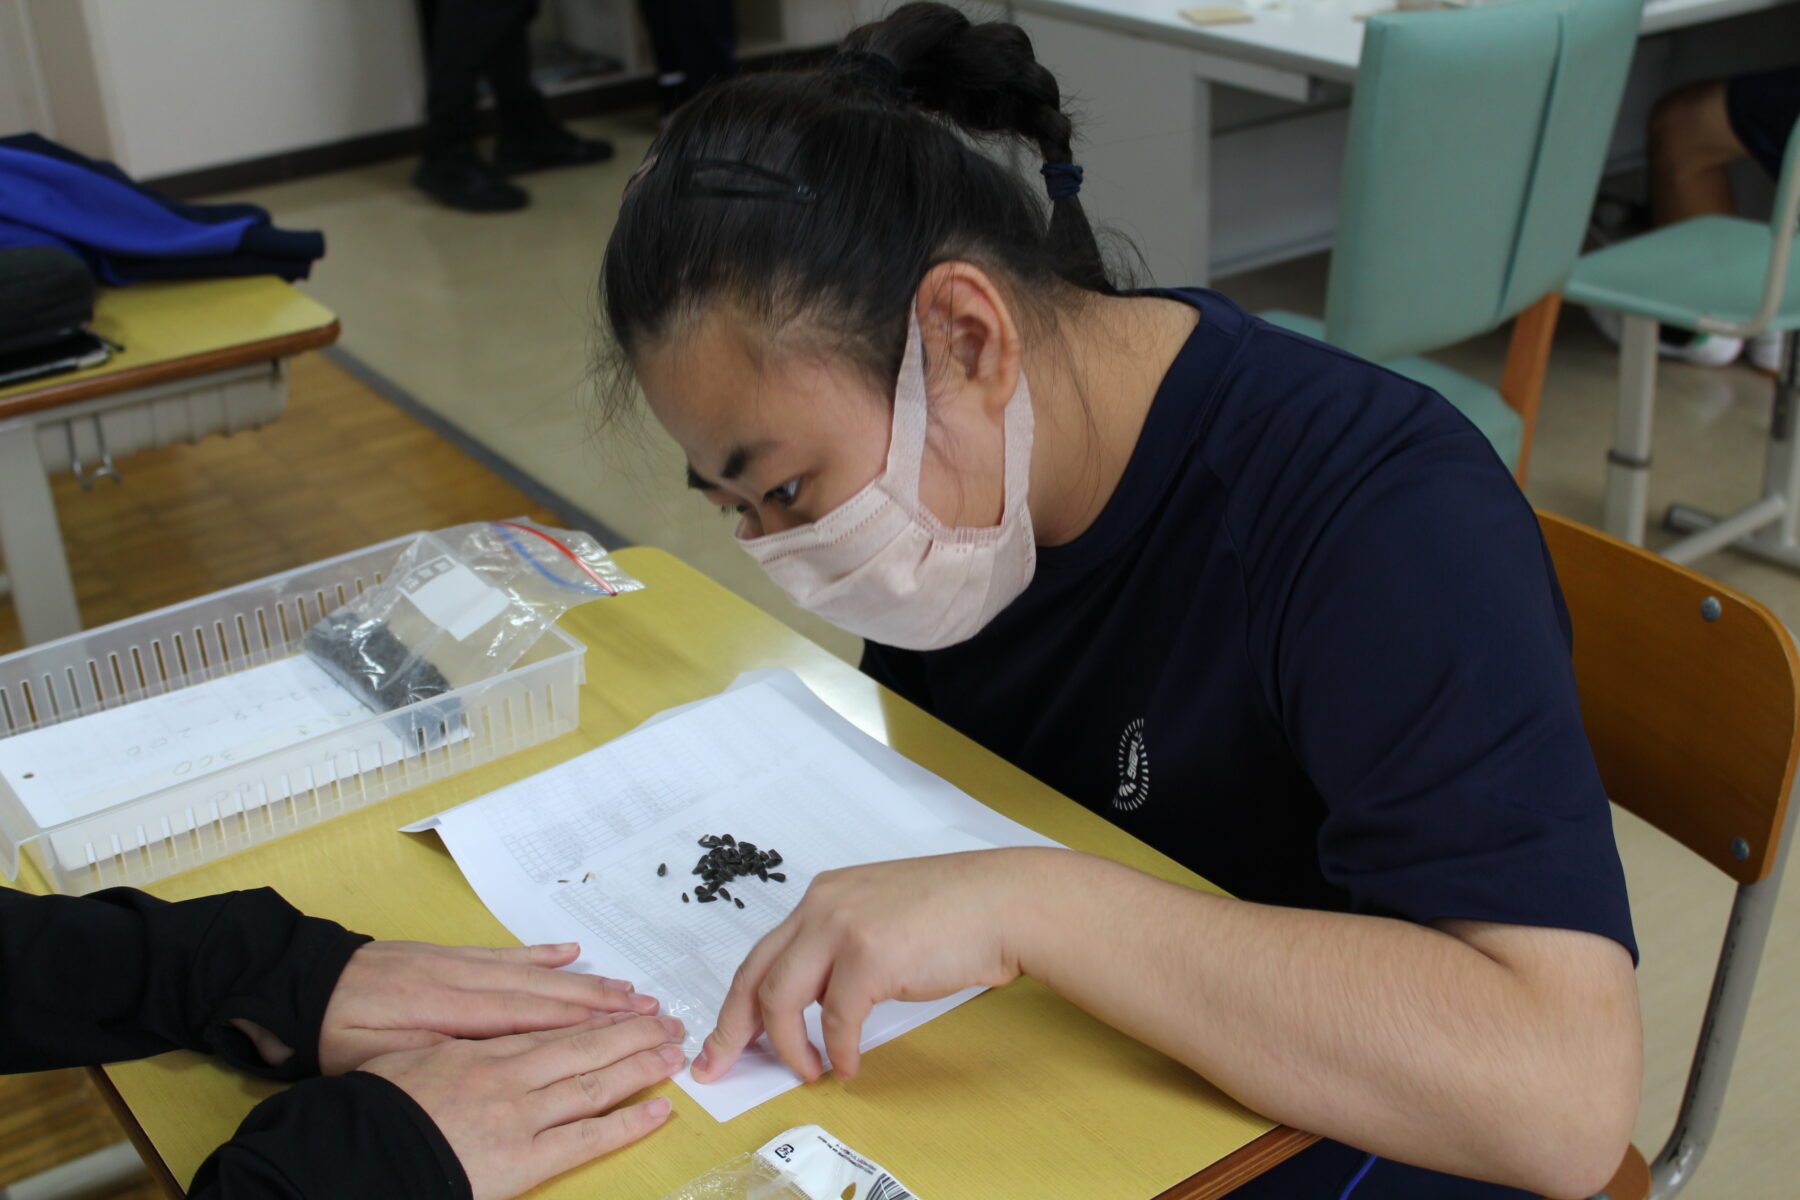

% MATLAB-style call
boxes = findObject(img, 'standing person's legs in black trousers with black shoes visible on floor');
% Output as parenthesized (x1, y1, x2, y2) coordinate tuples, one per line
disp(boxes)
(412, 0, 612, 212)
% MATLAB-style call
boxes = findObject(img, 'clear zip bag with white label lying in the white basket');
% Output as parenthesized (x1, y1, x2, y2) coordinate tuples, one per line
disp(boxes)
(302, 518, 644, 712)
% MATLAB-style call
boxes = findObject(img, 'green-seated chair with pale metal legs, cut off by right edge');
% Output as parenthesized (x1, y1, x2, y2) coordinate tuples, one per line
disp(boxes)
(1568, 126, 1800, 569)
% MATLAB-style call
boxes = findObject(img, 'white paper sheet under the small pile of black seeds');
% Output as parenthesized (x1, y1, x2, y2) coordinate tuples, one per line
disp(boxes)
(409, 671, 1055, 1121)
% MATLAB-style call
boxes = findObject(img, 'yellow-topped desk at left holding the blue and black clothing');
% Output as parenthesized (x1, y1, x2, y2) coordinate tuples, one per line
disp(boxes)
(0, 275, 338, 646)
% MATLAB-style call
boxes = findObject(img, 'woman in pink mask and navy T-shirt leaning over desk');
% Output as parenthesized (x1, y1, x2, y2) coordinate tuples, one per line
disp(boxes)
(601, 4, 1640, 1200)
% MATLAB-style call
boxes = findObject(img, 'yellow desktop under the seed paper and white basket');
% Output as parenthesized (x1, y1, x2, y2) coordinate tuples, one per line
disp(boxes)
(10, 549, 1312, 1200)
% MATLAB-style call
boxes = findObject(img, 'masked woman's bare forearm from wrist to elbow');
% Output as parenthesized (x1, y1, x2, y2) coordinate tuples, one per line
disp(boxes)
(1010, 851, 1638, 1195)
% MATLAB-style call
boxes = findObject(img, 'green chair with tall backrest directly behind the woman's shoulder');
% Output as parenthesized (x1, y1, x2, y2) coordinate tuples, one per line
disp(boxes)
(1264, 0, 1643, 482)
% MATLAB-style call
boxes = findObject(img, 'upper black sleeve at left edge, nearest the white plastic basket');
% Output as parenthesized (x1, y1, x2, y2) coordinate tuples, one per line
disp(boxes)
(0, 887, 369, 1079)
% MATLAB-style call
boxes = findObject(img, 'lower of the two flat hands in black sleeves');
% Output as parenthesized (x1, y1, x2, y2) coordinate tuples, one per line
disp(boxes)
(362, 1013, 682, 1200)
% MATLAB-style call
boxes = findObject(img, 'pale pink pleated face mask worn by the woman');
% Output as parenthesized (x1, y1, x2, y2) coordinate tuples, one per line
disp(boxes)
(738, 317, 1037, 649)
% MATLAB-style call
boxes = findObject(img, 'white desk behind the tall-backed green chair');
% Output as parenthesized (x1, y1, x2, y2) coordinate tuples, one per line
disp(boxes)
(988, 0, 1800, 286)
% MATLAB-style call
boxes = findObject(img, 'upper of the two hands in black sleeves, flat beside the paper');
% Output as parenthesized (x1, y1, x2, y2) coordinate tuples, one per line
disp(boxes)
(232, 941, 659, 1074)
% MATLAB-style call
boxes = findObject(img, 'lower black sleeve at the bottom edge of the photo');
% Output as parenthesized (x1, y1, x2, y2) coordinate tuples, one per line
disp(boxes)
(187, 1070, 470, 1200)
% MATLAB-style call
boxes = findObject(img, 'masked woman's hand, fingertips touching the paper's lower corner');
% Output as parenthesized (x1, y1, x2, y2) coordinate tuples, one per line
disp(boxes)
(693, 849, 1042, 1083)
